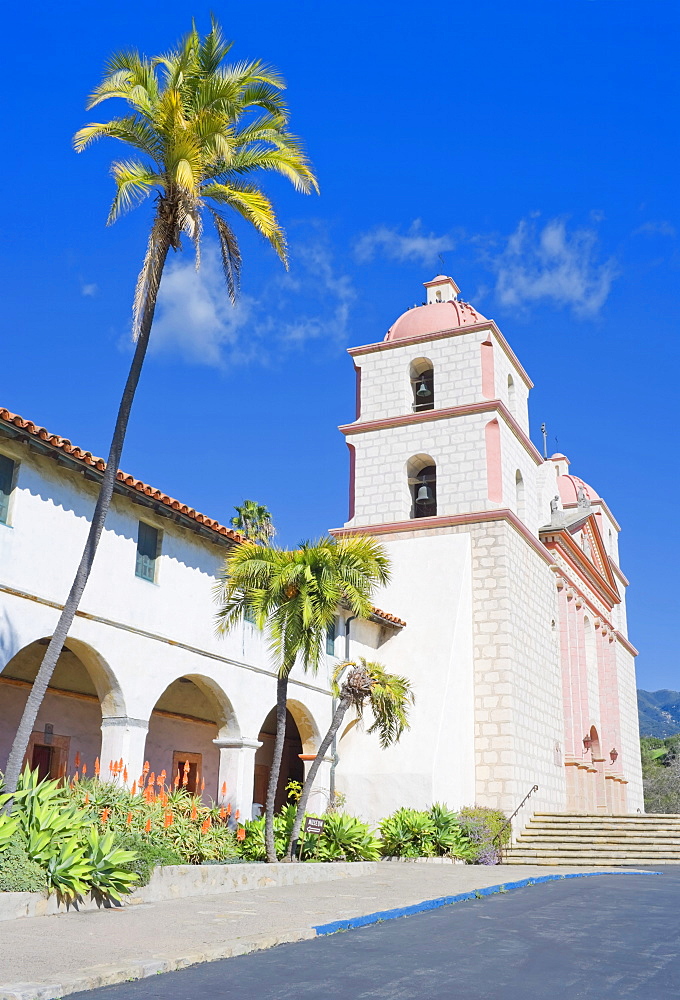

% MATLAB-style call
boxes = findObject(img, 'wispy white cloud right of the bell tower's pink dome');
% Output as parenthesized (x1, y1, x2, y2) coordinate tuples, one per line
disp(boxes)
(486, 219, 617, 316)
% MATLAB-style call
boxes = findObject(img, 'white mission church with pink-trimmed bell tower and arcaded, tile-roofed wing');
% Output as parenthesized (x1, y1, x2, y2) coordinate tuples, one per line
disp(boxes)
(0, 276, 644, 822)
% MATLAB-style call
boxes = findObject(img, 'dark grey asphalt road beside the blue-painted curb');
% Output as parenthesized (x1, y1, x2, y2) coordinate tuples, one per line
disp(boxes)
(71, 867, 680, 1000)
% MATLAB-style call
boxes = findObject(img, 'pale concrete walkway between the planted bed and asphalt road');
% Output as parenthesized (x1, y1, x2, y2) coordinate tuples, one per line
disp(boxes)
(0, 862, 658, 1000)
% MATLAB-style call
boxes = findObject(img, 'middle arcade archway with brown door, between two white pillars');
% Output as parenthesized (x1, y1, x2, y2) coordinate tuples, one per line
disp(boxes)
(144, 674, 238, 801)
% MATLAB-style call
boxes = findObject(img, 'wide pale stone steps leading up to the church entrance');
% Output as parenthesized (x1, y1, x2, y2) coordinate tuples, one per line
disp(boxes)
(504, 813, 680, 868)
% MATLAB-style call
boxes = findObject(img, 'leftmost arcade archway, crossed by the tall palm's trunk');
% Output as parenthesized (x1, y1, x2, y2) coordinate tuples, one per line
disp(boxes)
(0, 636, 125, 778)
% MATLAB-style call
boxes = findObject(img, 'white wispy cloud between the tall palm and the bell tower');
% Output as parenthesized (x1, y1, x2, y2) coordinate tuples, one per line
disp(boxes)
(151, 240, 355, 368)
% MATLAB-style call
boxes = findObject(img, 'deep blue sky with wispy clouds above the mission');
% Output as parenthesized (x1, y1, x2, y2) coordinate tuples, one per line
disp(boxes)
(0, 0, 680, 689)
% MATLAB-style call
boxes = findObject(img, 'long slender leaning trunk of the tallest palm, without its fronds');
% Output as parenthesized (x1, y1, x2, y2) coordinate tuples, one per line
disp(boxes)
(4, 217, 171, 796)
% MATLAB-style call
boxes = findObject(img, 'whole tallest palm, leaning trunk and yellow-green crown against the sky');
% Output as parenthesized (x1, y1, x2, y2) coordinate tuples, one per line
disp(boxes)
(5, 20, 317, 792)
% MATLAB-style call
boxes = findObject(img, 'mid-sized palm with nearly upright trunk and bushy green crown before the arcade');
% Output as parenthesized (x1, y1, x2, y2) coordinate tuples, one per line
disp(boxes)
(216, 535, 389, 861)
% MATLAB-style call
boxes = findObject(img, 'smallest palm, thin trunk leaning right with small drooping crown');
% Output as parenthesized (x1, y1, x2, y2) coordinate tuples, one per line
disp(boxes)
(285, 656, 414, 861)
